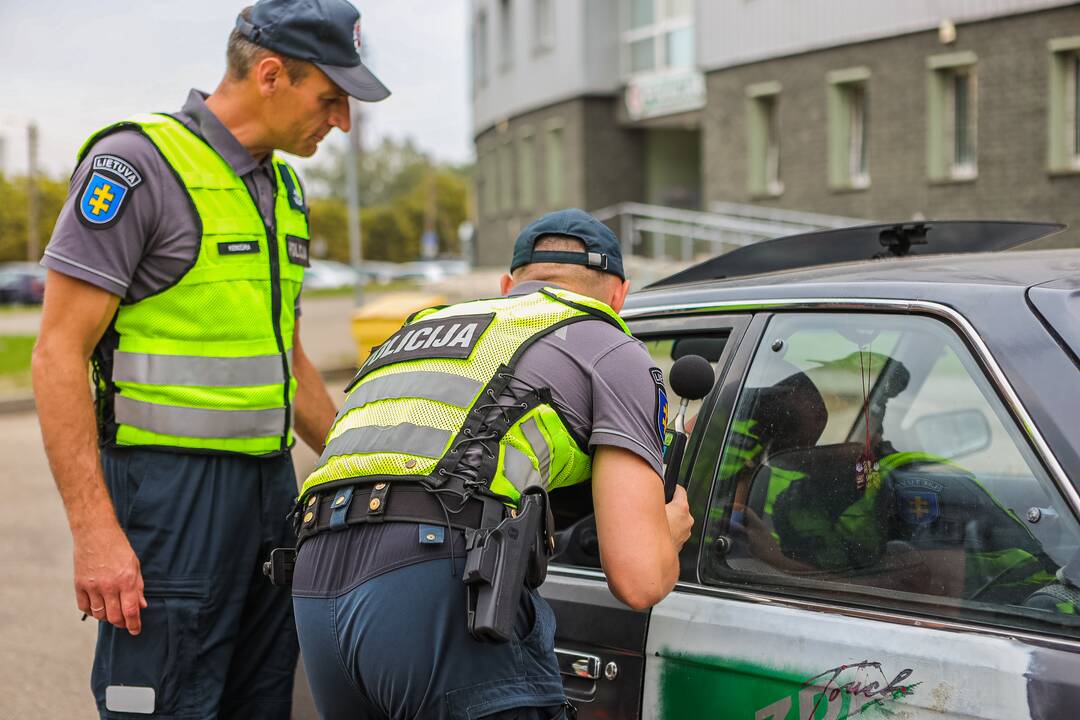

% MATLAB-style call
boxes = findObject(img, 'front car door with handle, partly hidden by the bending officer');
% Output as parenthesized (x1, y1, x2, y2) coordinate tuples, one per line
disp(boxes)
(540, 316, 747, 719)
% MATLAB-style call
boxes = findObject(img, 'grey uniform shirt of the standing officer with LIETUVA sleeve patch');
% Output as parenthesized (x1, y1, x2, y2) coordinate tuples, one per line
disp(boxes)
(41, 90, 300, 310)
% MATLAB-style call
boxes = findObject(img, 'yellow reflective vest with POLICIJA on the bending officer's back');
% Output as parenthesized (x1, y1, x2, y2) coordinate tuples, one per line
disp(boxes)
(300, 288, 630, 505)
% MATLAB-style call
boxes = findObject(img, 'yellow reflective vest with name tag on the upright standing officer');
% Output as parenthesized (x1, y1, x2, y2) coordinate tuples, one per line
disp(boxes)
(79, 114, 309, 456)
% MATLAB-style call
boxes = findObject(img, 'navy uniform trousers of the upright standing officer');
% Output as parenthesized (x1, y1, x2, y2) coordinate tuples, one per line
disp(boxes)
(91, 449, 298, 720)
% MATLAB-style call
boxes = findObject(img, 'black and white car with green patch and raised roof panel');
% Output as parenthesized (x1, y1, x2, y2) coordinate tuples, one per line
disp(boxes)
(541, 222, 1080, 720)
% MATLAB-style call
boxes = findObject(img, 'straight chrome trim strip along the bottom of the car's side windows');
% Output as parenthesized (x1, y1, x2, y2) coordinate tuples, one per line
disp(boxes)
(549, 565, 1080, 653)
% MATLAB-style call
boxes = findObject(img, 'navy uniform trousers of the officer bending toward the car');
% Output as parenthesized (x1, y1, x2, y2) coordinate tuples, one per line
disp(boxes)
(294, 524, 565, 720)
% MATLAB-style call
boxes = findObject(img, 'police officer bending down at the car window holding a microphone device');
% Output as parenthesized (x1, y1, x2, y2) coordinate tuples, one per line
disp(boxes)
(293, 209, 693, 719)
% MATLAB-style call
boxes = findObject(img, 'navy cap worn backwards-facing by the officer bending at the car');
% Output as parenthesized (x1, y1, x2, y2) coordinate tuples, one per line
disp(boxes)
(510, 207, 626, 280)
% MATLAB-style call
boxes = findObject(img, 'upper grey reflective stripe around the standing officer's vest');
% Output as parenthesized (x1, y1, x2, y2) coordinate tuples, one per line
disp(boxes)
(112, 350, 293, 388)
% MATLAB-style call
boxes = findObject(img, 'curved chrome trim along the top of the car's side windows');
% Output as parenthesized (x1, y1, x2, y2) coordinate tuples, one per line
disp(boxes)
(621, 298, 1080, 521)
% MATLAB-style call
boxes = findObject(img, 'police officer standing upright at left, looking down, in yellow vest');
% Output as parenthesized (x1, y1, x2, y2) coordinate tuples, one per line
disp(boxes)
(33, 0, 389, 719)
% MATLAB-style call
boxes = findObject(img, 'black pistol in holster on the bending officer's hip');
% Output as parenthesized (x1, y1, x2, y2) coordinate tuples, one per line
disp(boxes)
(462, 487, 555, 642)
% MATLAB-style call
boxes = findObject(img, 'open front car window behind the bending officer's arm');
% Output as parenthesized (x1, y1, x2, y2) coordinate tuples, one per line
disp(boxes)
(551, 329, 728, 568)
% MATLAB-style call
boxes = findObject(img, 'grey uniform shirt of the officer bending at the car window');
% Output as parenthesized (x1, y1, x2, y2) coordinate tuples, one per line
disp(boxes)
(293, 282, 666, 597)
